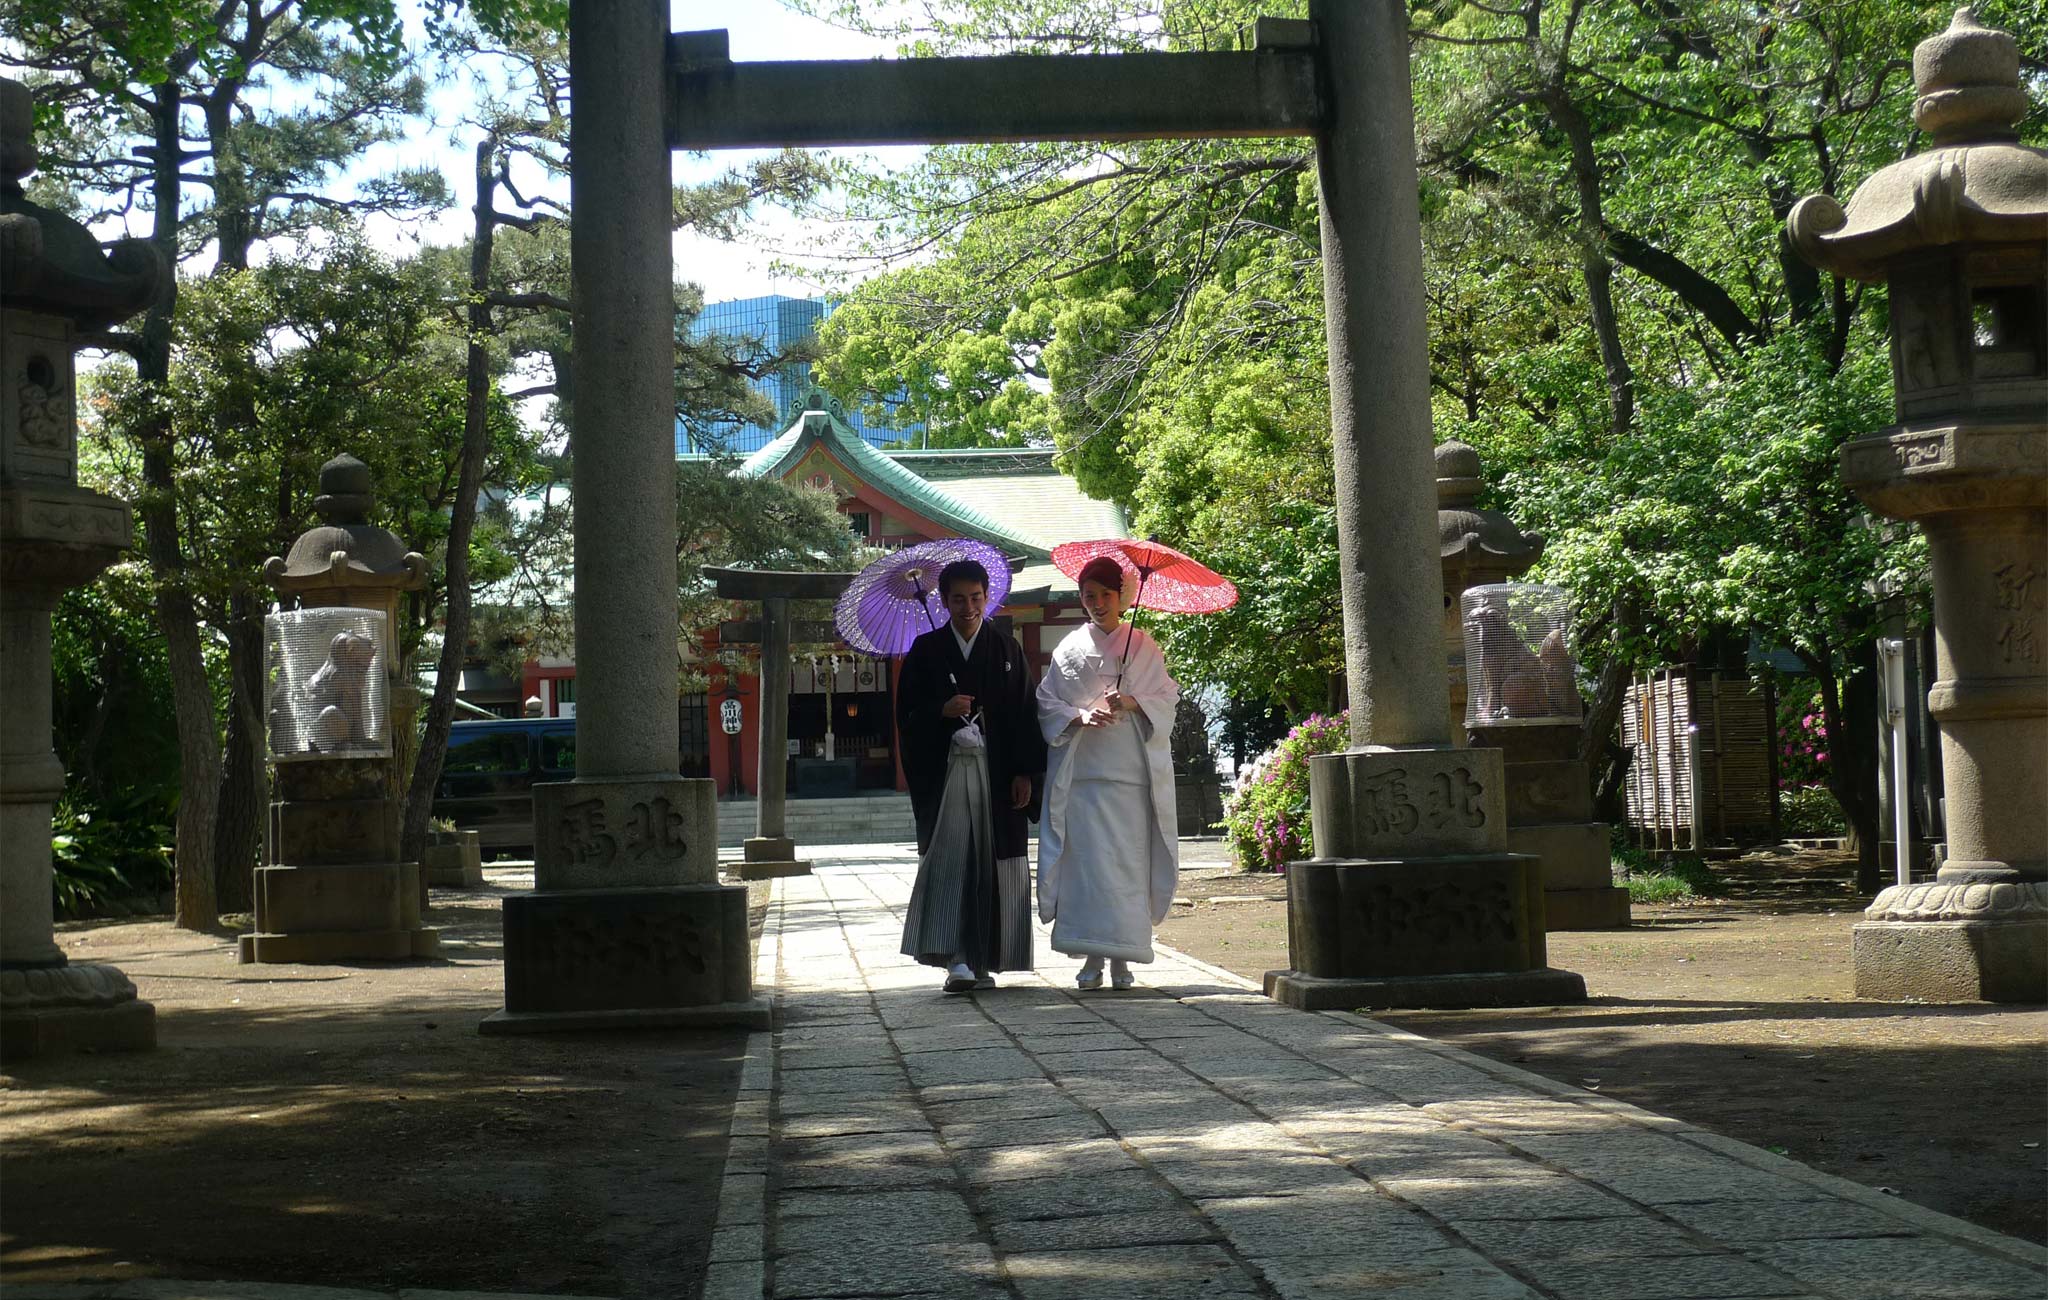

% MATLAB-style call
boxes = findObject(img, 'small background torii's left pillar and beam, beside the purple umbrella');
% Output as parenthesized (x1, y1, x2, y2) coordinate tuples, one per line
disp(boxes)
(705, 567, 854, 880)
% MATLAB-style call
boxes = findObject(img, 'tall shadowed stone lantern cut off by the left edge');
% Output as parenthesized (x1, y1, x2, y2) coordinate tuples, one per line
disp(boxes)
(0, 78, 170, 1060)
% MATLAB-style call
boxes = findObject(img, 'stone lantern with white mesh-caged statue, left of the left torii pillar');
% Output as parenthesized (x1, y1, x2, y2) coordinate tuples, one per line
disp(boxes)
(240, 454, 440, 962)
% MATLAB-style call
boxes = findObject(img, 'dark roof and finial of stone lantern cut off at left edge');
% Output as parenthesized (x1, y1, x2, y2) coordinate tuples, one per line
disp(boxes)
(0, 78, 170, 330)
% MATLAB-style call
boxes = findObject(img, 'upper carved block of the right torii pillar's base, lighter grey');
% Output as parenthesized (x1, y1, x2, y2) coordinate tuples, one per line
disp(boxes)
(1309, 747, 1507, 858)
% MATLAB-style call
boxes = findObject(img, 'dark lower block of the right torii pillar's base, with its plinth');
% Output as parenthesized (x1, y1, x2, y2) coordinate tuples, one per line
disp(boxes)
(1266, 854, 1585, 1011)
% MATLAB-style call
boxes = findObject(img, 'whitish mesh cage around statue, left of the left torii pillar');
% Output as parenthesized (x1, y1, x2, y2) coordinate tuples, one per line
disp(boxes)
(264, 606, 391, 762)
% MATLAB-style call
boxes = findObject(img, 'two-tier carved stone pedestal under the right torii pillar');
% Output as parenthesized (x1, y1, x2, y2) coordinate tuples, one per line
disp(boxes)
(1266, 747, 1585, 1011)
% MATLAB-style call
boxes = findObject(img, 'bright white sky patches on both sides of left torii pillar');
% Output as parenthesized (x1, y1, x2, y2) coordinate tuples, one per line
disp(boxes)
(360, 0, 922, 303)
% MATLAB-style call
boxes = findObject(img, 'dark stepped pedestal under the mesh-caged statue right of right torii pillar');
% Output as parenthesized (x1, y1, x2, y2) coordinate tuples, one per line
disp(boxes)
(1468, 727, 1628, 929)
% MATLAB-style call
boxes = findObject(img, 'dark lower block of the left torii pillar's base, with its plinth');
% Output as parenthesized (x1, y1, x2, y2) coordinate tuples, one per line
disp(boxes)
(479, 884, 768, 1034)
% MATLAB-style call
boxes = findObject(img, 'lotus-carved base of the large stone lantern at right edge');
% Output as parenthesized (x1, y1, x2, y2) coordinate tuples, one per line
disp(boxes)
(1849, 868, 2048, 1003)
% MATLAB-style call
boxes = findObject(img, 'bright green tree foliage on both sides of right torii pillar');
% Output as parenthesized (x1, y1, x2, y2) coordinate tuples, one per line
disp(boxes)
(811, 0, 1998, 761)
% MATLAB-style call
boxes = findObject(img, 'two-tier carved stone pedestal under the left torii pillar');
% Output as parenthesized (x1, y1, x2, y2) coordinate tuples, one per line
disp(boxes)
(479, 776, 770, 1034)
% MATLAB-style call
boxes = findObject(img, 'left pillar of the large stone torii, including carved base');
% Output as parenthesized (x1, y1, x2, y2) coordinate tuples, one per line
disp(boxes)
(479, 0, 770, 1034)
